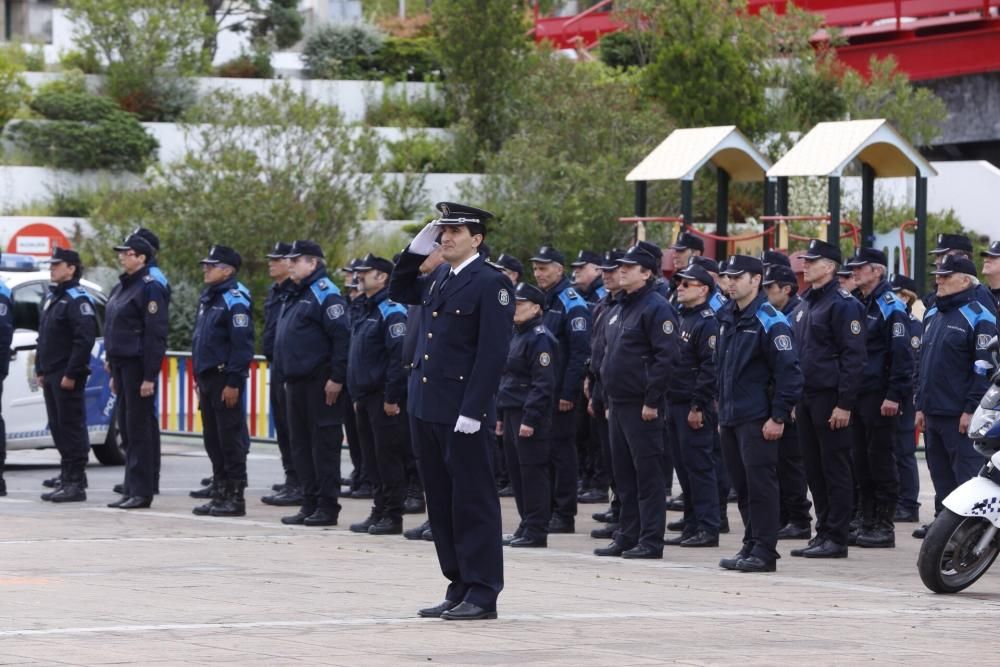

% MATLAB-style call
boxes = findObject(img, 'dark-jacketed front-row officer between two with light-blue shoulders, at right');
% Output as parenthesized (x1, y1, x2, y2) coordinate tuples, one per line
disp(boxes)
(791, 239, 866, 558)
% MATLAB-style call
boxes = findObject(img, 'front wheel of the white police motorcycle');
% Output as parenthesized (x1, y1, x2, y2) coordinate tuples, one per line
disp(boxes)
(917, 509, 1000, 593)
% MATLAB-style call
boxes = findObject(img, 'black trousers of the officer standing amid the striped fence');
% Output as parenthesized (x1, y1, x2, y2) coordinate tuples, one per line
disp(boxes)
(198, 371, 250, 483)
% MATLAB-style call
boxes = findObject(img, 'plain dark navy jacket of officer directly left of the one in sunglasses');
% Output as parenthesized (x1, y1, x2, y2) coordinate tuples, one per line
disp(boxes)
(601, 283, 678, 408)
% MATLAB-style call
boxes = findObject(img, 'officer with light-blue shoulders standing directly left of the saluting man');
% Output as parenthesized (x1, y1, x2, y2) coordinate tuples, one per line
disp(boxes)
(347, 253, 409, 535)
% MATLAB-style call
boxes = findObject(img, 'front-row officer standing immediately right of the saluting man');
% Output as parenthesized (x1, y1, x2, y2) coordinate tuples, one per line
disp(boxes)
(497, 283, 559, 547)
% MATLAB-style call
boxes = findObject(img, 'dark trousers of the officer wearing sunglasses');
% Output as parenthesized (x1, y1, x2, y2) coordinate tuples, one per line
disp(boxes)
(666, 402, 728, 535)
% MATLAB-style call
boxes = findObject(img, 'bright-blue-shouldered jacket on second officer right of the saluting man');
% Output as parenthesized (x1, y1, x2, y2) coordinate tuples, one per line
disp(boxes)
(545, 276, 591, 401)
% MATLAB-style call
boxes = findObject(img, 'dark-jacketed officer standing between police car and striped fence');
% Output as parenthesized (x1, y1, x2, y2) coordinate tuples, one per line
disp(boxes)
(104, 235, 170, 510)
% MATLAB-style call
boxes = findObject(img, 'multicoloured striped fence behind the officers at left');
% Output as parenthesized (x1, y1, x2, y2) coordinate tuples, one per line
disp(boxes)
(156, 352, 275, 441)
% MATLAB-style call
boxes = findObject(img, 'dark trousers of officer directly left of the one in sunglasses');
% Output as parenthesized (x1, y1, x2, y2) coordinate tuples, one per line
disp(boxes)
(608, 403, 667, 550)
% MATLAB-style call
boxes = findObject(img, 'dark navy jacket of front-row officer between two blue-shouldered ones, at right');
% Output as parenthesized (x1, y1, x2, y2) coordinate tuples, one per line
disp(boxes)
(792, 280, 867, 410)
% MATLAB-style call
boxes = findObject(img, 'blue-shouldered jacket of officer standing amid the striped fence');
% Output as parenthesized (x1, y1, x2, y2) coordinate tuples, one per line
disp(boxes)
(191, 277, 253, 387)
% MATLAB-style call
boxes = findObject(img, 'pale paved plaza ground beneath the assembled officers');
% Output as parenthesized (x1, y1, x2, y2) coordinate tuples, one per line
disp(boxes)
(0, 440, 1000, 667)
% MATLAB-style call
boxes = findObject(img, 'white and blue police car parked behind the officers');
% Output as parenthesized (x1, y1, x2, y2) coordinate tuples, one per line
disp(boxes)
(0, 253, 125, 465)
